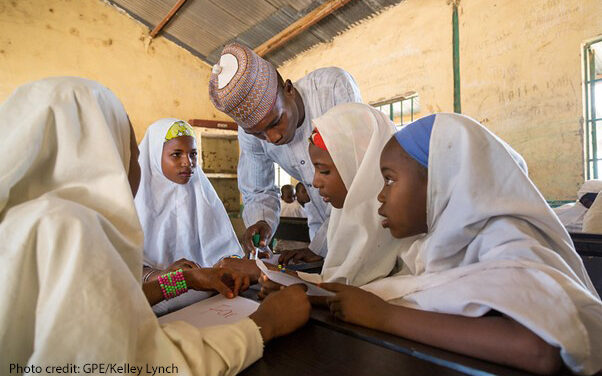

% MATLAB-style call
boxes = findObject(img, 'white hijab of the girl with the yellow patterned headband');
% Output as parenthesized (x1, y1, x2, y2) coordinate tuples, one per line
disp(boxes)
(135, 119, 244, 269)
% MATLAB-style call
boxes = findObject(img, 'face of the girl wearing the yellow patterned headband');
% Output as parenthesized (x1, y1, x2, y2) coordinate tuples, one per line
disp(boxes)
(161, 136, 197, 184)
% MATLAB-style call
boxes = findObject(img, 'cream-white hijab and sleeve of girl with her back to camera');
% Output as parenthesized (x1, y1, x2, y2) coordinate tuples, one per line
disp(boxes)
(0, 78, 262, 375)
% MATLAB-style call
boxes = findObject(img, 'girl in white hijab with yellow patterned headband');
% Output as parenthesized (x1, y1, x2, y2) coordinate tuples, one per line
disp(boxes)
(134, 119, 243, 316)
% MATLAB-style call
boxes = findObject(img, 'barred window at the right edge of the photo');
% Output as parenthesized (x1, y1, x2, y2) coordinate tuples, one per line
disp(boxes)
(583, 39, 602, 180)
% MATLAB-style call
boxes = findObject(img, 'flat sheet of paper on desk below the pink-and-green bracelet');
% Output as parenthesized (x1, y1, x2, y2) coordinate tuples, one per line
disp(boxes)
(159, 295, 259, 328)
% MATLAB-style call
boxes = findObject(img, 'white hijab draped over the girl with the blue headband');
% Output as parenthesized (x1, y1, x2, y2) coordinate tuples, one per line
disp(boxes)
(363, 114, 602, 374)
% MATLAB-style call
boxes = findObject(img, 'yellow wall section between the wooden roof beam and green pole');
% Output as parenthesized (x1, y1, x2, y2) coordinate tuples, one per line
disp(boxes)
(278, 0, 453, 116)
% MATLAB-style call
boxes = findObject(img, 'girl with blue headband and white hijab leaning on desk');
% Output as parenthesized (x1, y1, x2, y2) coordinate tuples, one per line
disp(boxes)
(323, 114, 602, 374)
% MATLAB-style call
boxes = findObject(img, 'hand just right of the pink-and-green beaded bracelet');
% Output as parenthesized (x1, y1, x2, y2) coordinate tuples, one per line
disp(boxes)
(189, 268, 250, 299)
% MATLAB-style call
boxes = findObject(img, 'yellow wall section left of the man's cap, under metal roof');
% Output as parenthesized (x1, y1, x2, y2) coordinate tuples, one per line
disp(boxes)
(0, 0, 228, 140)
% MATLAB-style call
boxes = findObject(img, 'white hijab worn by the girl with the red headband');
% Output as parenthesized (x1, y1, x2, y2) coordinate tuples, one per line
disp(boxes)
(313, 103, 400, 286)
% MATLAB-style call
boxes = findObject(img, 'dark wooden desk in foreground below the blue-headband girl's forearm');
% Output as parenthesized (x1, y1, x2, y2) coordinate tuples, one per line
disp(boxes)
(241, 290, 571, 376)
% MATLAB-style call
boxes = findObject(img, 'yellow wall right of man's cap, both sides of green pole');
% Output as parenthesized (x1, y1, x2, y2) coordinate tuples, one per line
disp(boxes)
(279, 0, 602, 200)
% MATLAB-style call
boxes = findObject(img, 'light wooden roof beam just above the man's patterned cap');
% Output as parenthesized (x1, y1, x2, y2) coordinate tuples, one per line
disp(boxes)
(255, 0, 351, 56)
